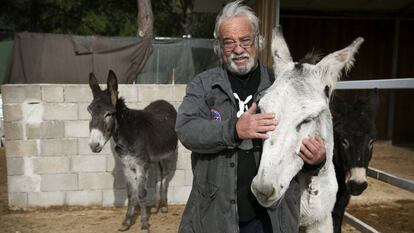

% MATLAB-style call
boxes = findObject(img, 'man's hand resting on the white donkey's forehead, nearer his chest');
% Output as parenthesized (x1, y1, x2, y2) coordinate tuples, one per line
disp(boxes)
(236, 103, 277, 139)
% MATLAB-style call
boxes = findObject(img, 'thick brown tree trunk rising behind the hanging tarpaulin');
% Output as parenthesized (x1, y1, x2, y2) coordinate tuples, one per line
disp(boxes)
(137, 0, 154, 38)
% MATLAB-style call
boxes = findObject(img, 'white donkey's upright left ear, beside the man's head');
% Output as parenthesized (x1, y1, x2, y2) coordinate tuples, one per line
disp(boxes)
(272, 25, 292, 78)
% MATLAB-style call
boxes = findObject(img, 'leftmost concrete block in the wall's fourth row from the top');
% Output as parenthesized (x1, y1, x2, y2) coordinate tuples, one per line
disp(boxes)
(5, 140, 39, 157)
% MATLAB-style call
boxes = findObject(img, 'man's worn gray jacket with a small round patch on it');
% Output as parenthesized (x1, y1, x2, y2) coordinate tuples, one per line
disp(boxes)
(176, 66, 300, 233)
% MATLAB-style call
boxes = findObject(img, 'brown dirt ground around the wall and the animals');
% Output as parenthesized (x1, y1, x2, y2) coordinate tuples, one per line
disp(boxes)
(0, 142, 414, 233)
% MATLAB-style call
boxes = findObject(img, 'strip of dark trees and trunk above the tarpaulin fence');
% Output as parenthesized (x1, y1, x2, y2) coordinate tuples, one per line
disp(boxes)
(0, 0, 216, 38)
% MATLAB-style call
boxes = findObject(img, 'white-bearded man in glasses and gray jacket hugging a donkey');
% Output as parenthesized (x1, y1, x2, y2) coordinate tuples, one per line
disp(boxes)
(176, 1, 325, 233)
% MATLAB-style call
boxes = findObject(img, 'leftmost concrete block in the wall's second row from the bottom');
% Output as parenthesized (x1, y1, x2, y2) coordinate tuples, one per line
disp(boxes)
(7, 175, 40, 193)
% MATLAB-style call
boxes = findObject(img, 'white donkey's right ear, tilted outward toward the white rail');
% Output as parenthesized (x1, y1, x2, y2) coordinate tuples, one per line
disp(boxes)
(317, 37, 364, 88)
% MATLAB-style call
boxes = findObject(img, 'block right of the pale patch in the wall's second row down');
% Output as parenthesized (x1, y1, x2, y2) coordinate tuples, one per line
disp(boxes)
(43, 103, 78, 121)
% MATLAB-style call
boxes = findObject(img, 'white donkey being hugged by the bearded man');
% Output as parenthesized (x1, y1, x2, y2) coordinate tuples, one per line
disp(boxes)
(251, 28, 364, 233)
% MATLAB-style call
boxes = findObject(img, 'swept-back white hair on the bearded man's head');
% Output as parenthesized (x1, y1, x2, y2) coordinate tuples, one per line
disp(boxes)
(214, 0, 265, 61)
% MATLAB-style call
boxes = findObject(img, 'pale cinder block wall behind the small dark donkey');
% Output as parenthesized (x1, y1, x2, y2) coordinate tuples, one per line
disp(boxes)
(1, 84, 192, 208)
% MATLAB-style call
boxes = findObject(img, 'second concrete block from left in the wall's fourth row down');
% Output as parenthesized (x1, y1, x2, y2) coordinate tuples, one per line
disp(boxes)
(40, 139, 78, 156)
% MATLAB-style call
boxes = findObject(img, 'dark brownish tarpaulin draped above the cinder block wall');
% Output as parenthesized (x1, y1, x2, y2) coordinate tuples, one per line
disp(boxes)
(4, 32, 152, 84)
